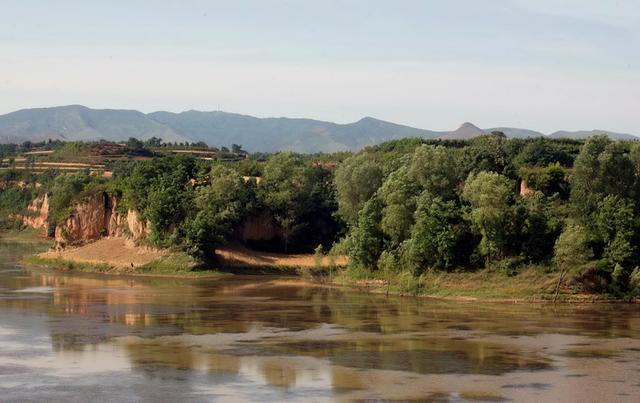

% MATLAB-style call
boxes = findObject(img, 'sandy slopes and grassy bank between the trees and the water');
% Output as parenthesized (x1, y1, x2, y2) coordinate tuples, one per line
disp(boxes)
(0, 229, 632, 302)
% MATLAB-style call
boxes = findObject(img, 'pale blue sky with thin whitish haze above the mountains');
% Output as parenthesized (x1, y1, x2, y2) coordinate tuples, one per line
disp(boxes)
(0, 0, 640, 134)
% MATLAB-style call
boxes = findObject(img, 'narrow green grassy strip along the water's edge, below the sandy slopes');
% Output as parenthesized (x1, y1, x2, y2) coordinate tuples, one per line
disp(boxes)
(0, 230, 639, 305)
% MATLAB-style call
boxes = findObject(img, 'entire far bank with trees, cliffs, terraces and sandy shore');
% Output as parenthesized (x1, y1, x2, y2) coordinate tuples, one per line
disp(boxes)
(0, 133, 640, 301)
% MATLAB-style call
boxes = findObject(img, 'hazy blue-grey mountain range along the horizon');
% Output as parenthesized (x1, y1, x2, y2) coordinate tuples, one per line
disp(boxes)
(0, 105, 640, 153)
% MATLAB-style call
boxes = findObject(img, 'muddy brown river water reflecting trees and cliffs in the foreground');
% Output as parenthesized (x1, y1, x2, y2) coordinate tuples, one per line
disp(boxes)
(0, 243, 640, 402)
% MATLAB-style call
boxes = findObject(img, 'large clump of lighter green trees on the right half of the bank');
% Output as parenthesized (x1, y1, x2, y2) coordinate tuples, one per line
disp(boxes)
(336, 133, 640, 295)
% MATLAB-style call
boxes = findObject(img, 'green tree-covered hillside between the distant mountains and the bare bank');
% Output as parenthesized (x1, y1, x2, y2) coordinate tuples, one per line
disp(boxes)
(0, 134, 640, 296)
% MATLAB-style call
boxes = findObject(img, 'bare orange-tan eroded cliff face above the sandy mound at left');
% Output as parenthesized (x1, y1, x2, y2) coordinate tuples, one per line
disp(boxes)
(22, 192, 149, 247)
